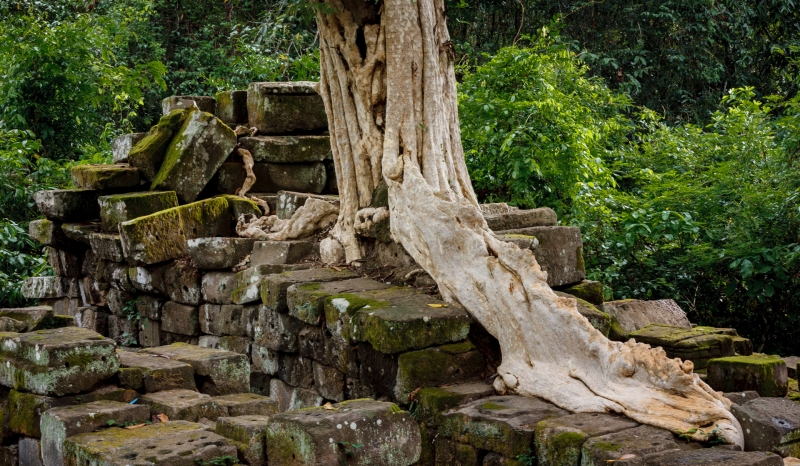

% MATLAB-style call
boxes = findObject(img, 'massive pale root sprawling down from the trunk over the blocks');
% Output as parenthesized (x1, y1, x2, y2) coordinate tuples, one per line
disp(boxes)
(384, 159, 743, 446)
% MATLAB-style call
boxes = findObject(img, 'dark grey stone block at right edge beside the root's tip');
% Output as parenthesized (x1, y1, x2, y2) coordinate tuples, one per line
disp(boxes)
(731, 398, 800, 457)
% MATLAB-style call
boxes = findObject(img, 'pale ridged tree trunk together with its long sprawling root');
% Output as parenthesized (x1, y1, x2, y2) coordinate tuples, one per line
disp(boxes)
(317, 0, 743, 445)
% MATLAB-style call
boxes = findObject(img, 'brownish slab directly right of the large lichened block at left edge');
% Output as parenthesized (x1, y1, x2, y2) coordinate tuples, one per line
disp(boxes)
(118, 351, 196, 393)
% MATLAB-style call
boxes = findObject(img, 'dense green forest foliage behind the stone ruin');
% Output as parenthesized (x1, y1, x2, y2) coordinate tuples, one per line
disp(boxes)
(0, 0, 800, 354)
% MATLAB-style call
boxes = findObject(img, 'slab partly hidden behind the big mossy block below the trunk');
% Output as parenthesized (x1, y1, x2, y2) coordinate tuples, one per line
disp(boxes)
(286, 278, 391, 325)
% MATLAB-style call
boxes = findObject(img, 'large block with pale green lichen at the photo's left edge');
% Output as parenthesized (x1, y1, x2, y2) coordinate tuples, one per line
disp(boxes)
(0, 327, 119, 396)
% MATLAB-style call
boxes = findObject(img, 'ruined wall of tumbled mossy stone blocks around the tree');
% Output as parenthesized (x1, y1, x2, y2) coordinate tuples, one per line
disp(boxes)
(0, 83, 800, 466)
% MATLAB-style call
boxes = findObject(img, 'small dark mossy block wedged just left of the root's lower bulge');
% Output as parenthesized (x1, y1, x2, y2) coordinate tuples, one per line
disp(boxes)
(416, 382, 495, 427)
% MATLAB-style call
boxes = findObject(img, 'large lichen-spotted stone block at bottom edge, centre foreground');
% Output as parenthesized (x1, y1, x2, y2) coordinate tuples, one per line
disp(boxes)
(266, 400, 421, 466)
